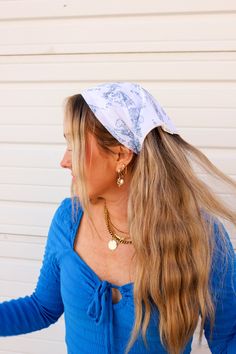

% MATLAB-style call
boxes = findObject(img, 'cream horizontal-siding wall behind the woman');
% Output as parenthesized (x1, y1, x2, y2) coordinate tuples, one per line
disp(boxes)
(0, 0, 236, 354)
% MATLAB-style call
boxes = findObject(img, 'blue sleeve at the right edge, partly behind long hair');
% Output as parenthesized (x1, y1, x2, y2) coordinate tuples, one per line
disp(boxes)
(204, 223, 236, 354)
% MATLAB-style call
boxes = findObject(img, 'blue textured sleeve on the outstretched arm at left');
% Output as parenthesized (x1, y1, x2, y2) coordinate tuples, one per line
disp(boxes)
(0, 199, 70, 336)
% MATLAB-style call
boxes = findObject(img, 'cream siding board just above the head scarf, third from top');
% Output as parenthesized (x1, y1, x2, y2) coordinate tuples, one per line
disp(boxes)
(0, 56, 236, 83)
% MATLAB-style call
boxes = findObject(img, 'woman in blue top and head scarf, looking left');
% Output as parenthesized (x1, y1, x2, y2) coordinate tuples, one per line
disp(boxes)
(0, 82, 236, 354)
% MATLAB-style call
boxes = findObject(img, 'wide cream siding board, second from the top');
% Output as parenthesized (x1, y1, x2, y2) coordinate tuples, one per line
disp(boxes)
(0, 12, 236, 55)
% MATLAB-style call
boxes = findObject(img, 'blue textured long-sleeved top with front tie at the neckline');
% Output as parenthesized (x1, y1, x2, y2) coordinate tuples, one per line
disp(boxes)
(0, 198, 236, 354)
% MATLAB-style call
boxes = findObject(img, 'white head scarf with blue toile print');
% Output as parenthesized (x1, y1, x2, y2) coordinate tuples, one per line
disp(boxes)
(81, 82, 178, 154)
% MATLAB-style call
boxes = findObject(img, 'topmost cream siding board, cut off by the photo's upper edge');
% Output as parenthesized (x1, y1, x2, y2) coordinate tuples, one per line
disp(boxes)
(0, 0, 236, 20)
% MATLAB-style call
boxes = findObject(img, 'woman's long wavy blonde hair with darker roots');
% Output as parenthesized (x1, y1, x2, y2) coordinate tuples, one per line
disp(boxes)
(65, 94, 236, 354)
